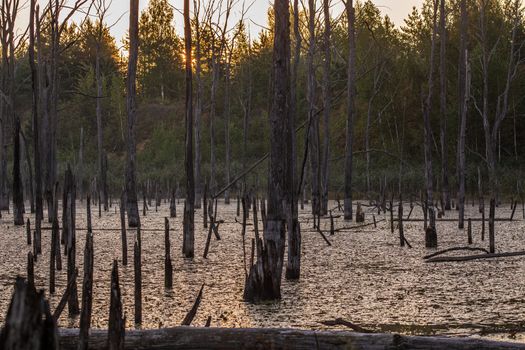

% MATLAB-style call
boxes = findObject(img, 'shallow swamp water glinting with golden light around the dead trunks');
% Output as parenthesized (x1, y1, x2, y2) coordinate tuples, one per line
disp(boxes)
(0, 201, 525, 342)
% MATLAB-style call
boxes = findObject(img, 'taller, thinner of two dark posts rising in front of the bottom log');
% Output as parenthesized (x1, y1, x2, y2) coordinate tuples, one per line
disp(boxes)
(78, 230, 93, 350)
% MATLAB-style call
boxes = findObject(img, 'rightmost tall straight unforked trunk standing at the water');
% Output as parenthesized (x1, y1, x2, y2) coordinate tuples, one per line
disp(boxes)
(458, 0, 464, 229)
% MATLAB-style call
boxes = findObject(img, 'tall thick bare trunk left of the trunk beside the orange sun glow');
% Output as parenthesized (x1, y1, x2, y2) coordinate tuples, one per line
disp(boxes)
(126, 0, 139, 227)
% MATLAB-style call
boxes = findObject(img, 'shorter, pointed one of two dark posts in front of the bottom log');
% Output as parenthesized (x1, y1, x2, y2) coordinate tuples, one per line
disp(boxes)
(107, 260, 125, 350)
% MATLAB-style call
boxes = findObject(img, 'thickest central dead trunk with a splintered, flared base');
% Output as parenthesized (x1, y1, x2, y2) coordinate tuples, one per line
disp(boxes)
(244, 0, 293, 302)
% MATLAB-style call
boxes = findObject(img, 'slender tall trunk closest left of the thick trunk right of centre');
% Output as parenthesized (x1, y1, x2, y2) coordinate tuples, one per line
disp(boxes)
(321, 0, 332, 215)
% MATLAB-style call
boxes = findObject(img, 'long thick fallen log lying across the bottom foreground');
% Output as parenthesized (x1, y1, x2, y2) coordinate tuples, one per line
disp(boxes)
(59, 327, 525, 350)
